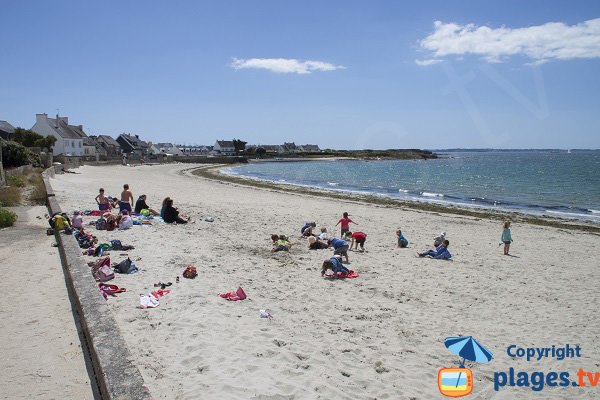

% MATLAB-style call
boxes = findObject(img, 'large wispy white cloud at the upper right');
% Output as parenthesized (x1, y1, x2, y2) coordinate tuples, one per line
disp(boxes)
(417, 18, 600, 65)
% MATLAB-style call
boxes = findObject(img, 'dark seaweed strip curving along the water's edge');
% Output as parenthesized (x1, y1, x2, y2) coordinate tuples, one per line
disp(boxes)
(191, 164, 600, 235)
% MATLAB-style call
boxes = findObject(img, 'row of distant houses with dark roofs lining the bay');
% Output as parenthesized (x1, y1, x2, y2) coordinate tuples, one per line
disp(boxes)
(0, 113, 319, 159)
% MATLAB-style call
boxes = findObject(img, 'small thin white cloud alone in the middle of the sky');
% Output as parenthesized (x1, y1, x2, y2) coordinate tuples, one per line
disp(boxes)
(231, 58, 346, 74)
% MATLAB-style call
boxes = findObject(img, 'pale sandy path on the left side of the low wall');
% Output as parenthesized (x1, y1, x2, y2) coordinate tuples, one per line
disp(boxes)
(0, 206, 94, 400)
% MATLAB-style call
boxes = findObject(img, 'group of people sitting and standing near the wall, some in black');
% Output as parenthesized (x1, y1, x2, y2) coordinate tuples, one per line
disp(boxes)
(95, 184, 190, 224)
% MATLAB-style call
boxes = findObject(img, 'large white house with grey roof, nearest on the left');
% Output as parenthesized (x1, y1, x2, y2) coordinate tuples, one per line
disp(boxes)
(31, 113, 85, 156)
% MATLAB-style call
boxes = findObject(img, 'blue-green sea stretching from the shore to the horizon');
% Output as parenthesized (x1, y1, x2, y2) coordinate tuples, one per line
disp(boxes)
(227, 150, 600, 223)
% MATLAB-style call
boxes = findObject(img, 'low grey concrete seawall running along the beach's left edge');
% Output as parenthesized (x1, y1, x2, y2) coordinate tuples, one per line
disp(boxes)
(42, 165, 152, 400)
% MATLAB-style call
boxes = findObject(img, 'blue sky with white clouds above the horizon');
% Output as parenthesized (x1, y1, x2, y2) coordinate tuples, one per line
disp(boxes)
(0, 0, 600, 149)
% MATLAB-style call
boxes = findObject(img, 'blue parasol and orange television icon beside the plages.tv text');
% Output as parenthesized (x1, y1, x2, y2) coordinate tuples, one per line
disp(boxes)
(438, 336, 494, 397)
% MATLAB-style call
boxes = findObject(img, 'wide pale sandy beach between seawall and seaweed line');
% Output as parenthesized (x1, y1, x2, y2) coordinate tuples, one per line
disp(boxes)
(51, 165, 600, 399)
